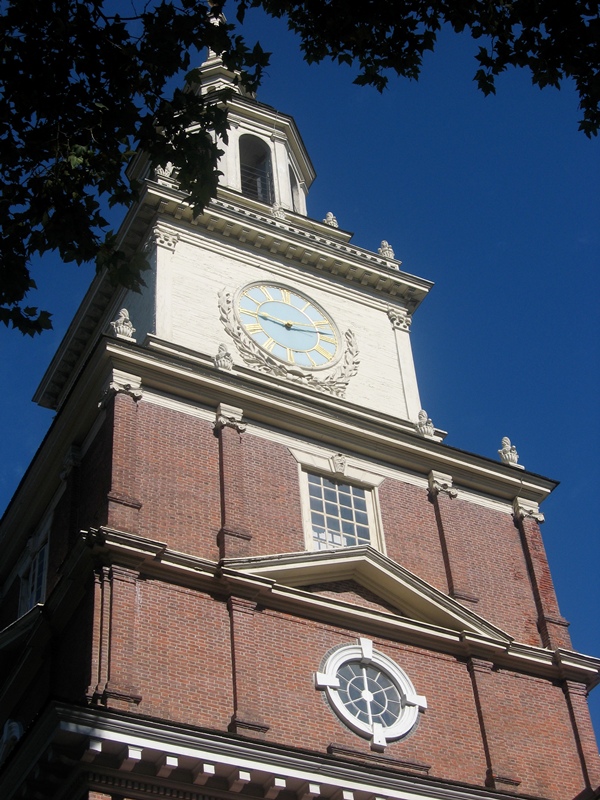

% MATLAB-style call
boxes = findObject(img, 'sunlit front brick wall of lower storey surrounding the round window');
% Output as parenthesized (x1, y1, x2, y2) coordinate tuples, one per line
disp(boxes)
(96, 580, 583, 800)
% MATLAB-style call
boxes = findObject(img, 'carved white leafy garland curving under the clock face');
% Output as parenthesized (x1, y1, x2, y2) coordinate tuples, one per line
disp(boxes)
(219, 289, 360, 397)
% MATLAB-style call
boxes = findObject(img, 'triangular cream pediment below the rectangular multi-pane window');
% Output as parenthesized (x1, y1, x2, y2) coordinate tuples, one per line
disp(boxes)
(223, 546, 512, 644)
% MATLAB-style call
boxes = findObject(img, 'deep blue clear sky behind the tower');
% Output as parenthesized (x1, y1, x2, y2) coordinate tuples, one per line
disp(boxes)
(0, 7, 600, 732)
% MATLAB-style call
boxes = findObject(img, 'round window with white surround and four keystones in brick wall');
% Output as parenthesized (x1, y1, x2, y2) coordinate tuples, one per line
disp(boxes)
(315, 639, 427, 750)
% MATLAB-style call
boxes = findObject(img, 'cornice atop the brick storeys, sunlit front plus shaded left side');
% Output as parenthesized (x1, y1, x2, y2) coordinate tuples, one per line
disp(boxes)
(0, 337, 556, 574)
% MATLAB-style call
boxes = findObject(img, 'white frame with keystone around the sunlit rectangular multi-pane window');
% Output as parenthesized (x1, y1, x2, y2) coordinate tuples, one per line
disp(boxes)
(289, 447, 385, 554)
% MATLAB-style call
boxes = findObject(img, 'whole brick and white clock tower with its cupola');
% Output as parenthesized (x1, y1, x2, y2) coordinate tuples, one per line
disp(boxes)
(0, 50, 600, 800)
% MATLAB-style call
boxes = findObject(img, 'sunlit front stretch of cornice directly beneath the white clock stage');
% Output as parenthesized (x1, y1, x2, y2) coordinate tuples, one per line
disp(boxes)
(69, 338, 556, 503)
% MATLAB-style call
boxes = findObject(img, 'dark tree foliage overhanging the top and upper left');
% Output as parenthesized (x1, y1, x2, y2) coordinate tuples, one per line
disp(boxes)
(0, 0, 600, 335)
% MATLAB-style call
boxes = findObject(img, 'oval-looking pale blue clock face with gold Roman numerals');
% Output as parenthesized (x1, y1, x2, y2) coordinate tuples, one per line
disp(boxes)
(236, 283, 340, 369)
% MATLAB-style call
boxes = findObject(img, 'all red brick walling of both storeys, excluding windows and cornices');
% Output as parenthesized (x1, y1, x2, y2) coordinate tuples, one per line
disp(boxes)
(3, 386, 598, 800)
